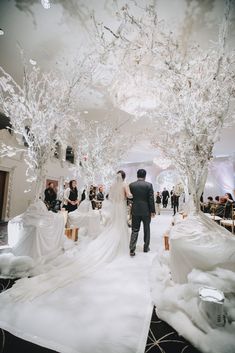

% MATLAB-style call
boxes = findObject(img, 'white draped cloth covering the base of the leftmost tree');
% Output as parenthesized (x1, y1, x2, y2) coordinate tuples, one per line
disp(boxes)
(8, 200, 65, 259)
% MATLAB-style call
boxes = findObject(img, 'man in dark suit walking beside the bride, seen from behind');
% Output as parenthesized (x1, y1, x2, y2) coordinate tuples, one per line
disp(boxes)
(129, 169, 155, 256)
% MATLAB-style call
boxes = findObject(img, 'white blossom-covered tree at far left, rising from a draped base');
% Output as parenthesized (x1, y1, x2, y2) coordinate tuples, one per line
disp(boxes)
(0, 57, 78, 199)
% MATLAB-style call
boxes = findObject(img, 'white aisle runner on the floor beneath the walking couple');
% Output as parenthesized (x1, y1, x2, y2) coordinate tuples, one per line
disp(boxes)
(0, 210, 173, 353)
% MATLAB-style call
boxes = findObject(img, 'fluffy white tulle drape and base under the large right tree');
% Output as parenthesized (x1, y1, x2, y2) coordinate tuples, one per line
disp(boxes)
(151, 213, 235, 353)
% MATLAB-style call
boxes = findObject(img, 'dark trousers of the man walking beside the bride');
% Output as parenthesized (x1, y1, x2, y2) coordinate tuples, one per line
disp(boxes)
(130, 215, 151, 252)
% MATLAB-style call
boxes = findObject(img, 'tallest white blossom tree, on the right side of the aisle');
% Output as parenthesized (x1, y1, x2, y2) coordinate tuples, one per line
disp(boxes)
(149, 2, 235, 213)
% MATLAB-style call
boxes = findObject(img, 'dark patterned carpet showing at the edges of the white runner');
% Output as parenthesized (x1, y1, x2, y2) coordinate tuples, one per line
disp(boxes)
(0, 278, 200, 353)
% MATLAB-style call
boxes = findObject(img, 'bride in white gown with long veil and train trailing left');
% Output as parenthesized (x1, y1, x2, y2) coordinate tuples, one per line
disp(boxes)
(0, 170, 132, 301)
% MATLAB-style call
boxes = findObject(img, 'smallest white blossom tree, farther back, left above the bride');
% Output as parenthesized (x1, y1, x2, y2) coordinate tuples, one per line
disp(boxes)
(72, 120, 135, 186)
